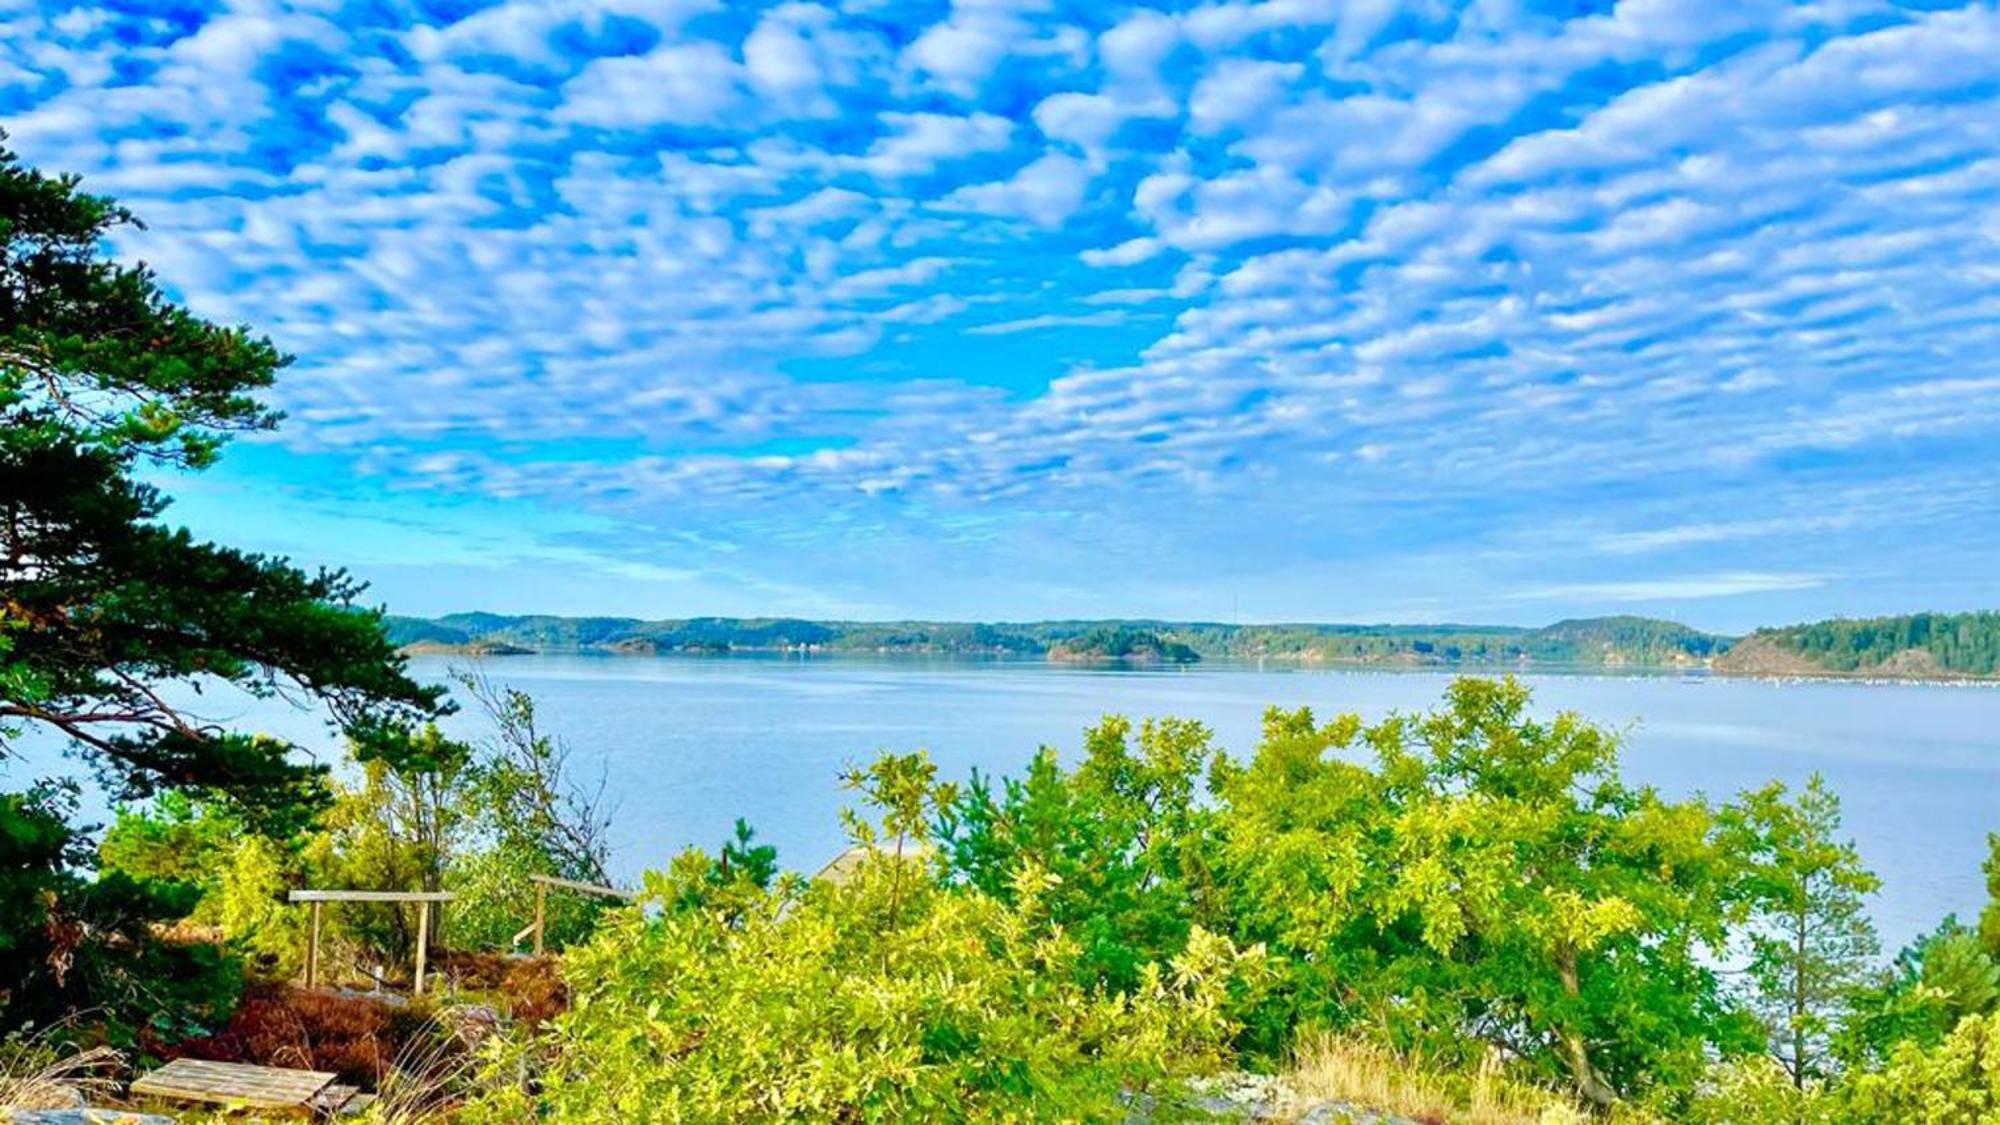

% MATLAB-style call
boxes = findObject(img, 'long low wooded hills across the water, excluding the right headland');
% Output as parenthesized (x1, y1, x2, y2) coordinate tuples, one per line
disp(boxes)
(386, 613, 1730, 667)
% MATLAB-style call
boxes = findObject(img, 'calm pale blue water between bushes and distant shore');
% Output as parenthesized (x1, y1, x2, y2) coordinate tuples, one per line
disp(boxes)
(15, 655, 2000, 949)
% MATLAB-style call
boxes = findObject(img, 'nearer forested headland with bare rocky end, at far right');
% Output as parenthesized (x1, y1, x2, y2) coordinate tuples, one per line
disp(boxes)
(1716, 613, 2000, 679)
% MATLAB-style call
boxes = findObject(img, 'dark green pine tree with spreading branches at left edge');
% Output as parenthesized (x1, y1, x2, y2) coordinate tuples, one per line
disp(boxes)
(0, 133, 442, 1033)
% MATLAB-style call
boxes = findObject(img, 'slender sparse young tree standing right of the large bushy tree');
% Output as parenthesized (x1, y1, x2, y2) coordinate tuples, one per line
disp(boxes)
(1722, 775, 1882, 1087)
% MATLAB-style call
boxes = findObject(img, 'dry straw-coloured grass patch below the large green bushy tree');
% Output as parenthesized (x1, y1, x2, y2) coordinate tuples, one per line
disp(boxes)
(1286, 1035, 1590, 1125)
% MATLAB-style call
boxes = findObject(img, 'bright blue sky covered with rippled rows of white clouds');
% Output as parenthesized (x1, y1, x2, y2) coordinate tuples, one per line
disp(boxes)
(0, 0, 2000, 629)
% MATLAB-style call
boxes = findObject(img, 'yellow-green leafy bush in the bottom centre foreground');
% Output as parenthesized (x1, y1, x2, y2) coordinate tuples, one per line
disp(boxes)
(470, 755, 1256, 1123)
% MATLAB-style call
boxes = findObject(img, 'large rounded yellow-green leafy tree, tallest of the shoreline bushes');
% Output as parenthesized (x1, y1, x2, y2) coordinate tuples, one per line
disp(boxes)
(1218, 679, 1750, 1103)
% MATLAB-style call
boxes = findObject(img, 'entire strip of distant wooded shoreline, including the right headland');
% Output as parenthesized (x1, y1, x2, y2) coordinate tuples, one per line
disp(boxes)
(384, 613, 2000, 685)
